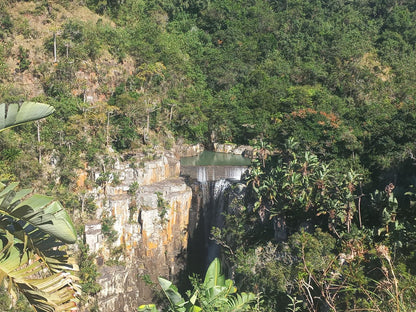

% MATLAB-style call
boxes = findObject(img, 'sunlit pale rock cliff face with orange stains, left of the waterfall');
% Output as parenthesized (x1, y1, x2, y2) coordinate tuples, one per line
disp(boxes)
(85, 154, 192, 311)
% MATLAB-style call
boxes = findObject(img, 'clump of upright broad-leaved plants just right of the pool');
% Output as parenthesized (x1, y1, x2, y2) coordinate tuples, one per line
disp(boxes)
(247, 139, 360, 235)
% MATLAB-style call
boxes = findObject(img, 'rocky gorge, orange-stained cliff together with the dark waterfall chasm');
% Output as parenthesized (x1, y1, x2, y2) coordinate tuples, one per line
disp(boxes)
(84, 145, 249, 311)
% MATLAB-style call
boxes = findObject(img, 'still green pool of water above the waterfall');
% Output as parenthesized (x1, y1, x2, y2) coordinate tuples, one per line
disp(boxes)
(181, 151, 251, 166)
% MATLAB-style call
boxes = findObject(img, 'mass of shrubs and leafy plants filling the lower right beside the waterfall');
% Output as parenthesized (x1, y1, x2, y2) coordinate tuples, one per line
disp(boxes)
(213, 140, 414, 312)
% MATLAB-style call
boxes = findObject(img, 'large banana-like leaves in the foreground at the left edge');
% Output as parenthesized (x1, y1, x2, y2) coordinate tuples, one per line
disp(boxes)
(0, 102, 79, 312)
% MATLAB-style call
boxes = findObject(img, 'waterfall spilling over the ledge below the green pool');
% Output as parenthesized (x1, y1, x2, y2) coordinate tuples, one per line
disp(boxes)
(181, 155, 247, 275)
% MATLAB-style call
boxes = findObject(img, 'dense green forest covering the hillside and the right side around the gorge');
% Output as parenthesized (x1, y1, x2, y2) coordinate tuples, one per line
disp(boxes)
(0, 0, 416, 311)
